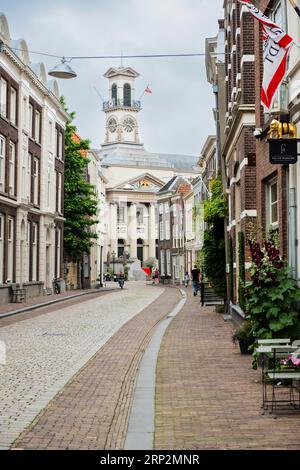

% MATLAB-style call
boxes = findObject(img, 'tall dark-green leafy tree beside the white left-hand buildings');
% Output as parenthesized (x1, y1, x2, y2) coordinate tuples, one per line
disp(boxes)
(61, 97, 98, 261)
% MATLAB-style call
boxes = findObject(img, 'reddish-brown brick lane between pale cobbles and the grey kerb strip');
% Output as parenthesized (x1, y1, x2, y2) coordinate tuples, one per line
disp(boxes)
(12, 289, 180, 449)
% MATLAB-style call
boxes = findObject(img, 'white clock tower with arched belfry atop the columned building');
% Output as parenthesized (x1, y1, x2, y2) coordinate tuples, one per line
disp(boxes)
(103, 67, 141, 146)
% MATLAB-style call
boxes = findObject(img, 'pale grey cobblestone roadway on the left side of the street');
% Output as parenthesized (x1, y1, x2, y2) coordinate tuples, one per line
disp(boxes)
(0, 283, 163, 448)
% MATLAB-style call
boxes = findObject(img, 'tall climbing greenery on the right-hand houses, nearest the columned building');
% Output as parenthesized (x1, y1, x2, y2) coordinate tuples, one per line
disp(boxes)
(202, 177, 227, 299)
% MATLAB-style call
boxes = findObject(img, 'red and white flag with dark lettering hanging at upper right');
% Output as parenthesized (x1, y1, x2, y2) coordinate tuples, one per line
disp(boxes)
(239, 0, 294, 109)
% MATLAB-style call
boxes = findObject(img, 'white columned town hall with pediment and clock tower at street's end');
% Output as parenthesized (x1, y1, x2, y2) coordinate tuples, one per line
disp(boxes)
(95, 67, 197, 278)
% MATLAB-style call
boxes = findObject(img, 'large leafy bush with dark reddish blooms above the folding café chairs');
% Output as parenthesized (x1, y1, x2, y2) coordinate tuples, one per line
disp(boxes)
(245, 232, 300, 368)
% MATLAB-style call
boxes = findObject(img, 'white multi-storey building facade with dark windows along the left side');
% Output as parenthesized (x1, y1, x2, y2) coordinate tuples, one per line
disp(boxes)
(0, 14, 68, 303)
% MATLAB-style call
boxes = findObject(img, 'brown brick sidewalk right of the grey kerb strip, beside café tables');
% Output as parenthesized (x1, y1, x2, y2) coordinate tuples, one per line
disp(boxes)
(155, 296, 300, 450)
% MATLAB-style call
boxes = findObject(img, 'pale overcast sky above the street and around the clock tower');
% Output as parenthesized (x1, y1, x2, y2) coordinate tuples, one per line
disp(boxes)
(0, 0, 223, 155)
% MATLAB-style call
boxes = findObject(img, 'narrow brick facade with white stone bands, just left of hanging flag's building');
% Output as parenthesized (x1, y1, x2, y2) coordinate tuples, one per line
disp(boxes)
(220, 0, 257, 314)
